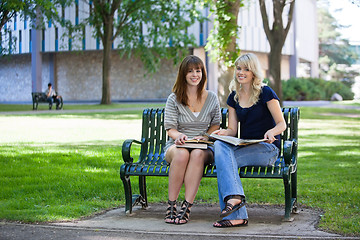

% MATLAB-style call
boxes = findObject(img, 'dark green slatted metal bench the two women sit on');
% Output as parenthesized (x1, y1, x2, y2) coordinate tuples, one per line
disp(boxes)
(120, 107, 300, 221)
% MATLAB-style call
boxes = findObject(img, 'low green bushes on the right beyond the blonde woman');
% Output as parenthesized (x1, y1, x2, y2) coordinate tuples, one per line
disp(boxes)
(282, 78, 354, 101)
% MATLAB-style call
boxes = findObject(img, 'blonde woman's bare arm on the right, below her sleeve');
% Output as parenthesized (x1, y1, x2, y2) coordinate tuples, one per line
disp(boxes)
(264, 99, 286, 143)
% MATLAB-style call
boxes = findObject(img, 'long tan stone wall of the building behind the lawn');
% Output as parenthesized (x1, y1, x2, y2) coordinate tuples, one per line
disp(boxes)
(0, 51, 177, 102)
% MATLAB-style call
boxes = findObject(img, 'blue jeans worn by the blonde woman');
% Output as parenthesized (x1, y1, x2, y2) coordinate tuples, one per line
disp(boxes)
(214, 141, 279, 220)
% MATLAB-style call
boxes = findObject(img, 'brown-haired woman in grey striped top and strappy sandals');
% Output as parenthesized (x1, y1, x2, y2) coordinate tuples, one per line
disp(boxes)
(164, 55, 220, 224)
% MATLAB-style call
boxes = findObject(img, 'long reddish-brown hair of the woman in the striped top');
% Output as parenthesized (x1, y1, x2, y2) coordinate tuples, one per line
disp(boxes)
(172, 55, 207, 106)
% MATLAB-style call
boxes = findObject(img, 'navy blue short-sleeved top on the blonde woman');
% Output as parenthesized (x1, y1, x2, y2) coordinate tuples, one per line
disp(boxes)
(226, 86, 280, 149)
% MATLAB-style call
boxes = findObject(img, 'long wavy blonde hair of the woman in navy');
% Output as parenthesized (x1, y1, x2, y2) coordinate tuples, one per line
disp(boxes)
(229, 53, 265, 105)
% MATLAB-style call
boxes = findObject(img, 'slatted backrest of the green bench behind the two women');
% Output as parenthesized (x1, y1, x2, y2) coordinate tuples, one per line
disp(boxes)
(139, 107, 300, 165)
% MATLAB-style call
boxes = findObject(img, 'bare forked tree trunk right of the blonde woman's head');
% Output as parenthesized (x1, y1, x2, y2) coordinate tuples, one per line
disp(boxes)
(259, 0, 295, 103)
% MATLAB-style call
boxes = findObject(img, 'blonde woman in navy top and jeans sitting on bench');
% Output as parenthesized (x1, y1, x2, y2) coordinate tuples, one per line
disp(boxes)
(213, 53, 286, 228)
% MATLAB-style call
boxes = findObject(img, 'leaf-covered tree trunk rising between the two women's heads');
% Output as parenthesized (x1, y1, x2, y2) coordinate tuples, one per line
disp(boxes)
(206, 0, 243, 105)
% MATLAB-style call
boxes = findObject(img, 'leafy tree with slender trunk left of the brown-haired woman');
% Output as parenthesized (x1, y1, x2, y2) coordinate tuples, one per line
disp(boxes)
(77, 0, 202, 104)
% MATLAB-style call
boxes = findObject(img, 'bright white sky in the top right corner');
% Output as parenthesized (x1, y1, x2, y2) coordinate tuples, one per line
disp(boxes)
(329, 0, 360, 44)
